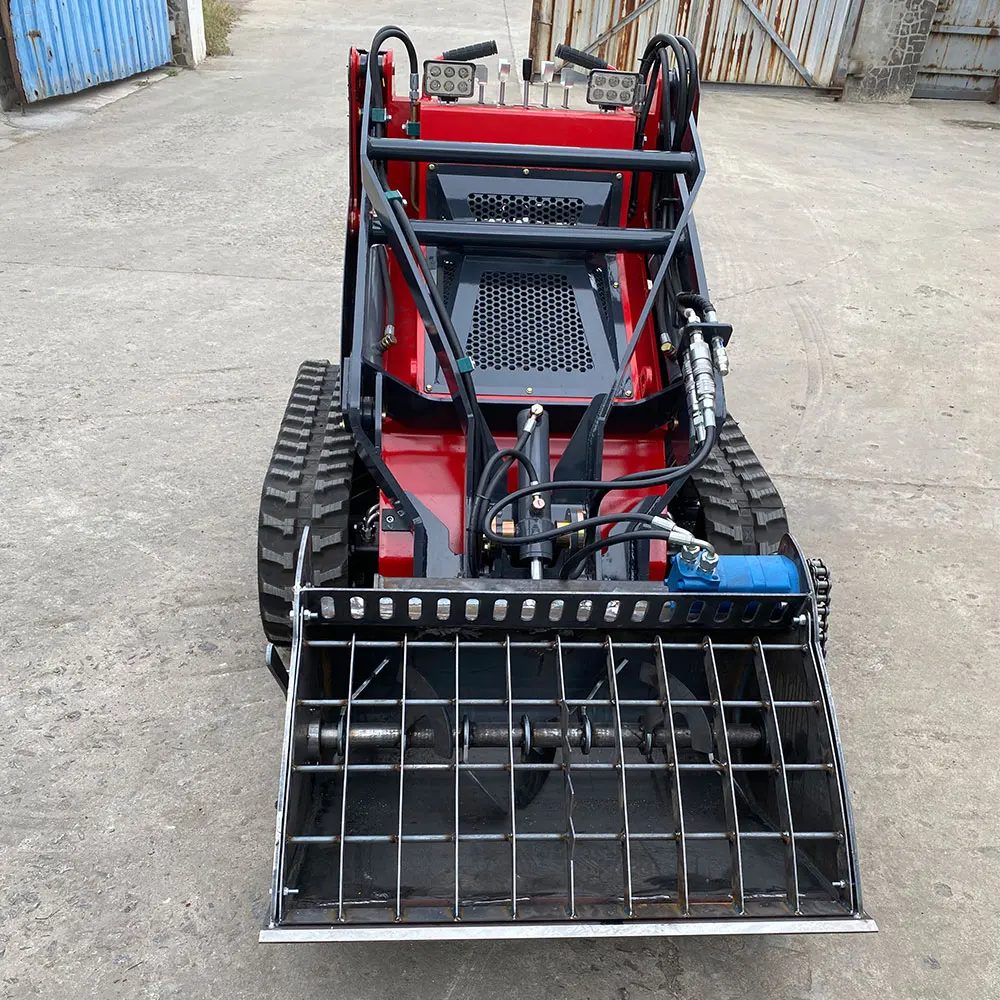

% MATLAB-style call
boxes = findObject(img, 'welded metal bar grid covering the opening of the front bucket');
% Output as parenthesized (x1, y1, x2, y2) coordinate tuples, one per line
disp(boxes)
(276, 635, 851, 925)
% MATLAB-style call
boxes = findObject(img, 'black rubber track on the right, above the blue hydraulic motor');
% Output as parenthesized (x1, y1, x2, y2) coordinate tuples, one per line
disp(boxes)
(690, 416, 788, 555)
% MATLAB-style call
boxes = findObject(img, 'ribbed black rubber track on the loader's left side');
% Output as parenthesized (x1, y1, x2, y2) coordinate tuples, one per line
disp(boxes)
(257, 361, 354, 645)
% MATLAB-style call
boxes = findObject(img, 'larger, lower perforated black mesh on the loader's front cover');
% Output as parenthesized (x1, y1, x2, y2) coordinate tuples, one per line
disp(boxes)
(466, 271, 594, 372)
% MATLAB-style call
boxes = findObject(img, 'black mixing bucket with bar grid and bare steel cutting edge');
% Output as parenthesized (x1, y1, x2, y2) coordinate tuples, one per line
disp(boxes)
(261, 532, 875, 941)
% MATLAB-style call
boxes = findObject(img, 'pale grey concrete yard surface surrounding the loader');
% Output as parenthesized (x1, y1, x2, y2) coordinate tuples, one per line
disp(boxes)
(0, 0, 1000, 1000)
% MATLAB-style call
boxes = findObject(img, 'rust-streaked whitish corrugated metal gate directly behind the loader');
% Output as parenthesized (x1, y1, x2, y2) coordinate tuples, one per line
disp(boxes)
(531, 0, 861, 88)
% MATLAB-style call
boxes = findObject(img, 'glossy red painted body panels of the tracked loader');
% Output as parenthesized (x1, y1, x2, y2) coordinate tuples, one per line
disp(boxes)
(349, 49, 689, 580)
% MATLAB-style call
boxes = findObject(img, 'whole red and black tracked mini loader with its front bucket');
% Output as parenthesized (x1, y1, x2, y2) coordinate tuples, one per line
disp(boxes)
(259, 27, 874, 941)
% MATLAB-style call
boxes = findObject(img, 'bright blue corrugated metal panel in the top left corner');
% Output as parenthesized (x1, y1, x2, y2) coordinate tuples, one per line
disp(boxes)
(0, 0, 171, 101)
